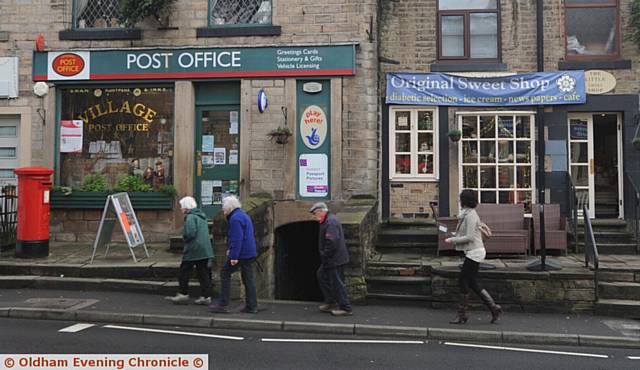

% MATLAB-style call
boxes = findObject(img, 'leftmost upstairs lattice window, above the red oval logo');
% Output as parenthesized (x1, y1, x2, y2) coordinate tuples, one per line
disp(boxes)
(73, 0, 122, 29)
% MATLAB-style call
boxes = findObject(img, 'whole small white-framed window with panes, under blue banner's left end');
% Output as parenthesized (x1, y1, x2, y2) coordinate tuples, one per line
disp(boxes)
(389, 107, 438, 180)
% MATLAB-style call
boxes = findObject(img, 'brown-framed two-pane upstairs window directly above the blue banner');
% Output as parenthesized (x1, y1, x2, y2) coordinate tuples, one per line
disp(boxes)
(438, 0, 500, 61)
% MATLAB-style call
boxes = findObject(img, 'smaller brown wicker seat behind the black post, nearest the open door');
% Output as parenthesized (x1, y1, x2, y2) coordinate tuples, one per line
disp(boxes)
(531, 204, 567, 255)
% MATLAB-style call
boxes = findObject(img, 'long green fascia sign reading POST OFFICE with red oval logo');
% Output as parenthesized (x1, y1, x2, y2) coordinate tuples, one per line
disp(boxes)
(33, 44, 356, 81)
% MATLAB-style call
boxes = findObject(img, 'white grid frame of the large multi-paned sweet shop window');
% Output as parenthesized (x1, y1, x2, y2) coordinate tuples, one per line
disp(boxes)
(456, 111, 536, 208)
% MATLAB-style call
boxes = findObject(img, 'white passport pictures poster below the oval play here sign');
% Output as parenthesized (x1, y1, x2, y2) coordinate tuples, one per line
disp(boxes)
(298, 154, 329, 198)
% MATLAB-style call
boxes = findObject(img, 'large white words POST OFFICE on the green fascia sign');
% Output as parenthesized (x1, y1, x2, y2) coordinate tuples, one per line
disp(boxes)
(127, 51, 242, 69)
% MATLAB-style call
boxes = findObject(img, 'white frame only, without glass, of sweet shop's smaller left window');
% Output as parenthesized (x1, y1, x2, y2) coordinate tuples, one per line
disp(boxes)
(389, 105, 440, 182)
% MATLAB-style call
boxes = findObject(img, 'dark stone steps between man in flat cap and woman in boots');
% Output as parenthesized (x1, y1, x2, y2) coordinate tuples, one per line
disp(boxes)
(366, 219, 438, 301)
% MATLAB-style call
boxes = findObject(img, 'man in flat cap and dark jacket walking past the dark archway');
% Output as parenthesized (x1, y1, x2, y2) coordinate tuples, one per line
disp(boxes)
(309, 202, 352, 316)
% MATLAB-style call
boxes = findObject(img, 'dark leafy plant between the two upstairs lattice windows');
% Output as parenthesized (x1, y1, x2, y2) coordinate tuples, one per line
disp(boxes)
(118, 0, 176, 28)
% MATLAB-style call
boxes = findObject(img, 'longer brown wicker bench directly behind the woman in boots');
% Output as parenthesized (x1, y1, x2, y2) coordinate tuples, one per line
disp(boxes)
(437, 204, 531, 254)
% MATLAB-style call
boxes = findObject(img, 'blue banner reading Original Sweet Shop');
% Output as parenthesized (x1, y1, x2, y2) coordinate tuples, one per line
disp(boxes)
(386, 71, 587, 107)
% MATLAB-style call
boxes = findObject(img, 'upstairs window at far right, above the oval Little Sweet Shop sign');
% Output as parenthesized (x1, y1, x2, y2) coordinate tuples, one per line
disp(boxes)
(564, 0, 620, 60)
